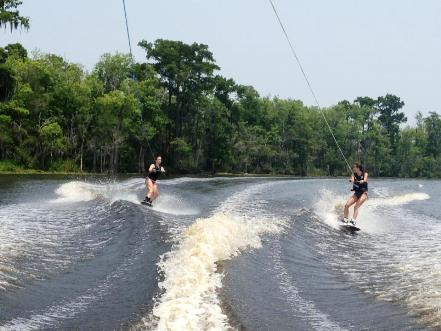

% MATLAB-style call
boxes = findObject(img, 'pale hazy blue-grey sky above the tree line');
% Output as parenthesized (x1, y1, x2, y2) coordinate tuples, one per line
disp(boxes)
(0, 0, 441, 123)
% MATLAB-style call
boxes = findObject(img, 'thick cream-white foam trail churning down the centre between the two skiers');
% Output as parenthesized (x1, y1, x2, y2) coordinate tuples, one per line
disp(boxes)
(153, 213, 280, 330)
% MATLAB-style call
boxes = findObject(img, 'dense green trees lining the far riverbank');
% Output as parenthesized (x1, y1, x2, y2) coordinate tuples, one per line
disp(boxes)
(0, 41, 441, 177)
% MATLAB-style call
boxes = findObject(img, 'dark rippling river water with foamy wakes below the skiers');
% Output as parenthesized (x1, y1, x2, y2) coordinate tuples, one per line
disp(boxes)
(0, 177, 434, 330)
